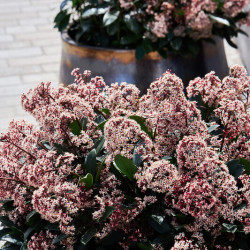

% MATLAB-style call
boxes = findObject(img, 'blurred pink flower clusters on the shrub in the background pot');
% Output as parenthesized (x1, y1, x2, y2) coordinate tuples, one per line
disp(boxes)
(119, 0, 250, 41)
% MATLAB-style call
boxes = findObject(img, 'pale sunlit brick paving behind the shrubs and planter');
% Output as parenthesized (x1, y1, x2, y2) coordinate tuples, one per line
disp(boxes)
(0, 0, 244, 132)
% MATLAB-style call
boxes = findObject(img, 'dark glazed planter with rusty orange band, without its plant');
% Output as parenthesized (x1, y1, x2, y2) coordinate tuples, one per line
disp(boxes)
(60, 33, 228, 93)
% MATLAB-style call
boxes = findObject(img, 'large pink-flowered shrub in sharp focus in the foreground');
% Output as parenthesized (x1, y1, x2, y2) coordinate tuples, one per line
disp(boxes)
(0, 65, 250, 250)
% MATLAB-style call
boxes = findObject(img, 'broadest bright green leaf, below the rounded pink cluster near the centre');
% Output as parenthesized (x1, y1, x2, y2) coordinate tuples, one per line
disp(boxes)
(115, 155, 137, 181)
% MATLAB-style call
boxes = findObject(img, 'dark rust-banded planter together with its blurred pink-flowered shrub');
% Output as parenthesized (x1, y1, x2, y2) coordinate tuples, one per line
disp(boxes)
(55, 0, 249, 93)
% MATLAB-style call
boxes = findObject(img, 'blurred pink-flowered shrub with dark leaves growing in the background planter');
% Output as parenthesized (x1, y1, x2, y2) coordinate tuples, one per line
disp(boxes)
(55, 0, 250, 59)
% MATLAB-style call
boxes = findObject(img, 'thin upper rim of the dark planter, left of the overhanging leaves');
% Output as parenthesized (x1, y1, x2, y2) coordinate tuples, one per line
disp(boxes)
(61, 31, 135, 52)
